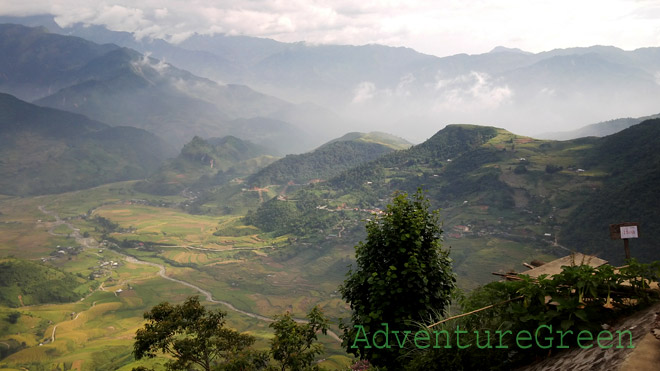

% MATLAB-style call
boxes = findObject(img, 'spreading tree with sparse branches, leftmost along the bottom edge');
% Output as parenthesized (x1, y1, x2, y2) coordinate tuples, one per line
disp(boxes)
(133, 296, 255, 371)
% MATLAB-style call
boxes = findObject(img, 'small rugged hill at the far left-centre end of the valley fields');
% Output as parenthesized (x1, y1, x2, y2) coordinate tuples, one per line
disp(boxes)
(135, 136, 277, 195)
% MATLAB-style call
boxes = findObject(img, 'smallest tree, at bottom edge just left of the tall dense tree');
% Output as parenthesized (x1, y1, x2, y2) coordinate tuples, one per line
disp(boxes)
(270, 307, 328, 371)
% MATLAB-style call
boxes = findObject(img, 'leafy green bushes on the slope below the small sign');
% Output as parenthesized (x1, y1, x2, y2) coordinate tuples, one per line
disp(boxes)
(407, 260, 660, 370)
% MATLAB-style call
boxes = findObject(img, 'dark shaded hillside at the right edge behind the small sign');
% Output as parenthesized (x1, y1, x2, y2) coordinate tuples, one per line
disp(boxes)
(561, 119, 660, 262)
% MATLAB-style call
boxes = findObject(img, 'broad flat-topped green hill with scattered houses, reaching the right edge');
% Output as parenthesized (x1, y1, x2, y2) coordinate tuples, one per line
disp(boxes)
(248, 119, 660, 263)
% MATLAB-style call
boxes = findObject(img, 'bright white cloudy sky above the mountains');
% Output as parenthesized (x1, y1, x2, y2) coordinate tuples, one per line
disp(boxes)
(0, 0, 660, 56)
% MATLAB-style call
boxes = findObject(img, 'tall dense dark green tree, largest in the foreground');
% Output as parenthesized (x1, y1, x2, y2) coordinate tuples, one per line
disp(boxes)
(340, 189, 456, 369)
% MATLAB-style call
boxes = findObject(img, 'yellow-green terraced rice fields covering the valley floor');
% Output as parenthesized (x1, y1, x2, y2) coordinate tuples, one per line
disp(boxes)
(0, 182, 352, 370)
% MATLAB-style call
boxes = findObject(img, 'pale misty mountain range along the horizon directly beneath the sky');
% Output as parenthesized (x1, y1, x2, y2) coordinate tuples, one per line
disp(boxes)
(5, 17, 660, 144)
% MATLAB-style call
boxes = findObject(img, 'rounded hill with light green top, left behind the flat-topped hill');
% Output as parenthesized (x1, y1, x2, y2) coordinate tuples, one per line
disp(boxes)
(247, 132, 411, 187)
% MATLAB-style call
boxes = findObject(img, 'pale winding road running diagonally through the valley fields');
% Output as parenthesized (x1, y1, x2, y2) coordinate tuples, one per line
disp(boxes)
(39, 205, 341, 342)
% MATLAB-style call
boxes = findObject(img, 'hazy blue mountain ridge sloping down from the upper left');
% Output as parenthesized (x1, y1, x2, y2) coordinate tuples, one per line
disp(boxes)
(0, 24, 332, 152)
